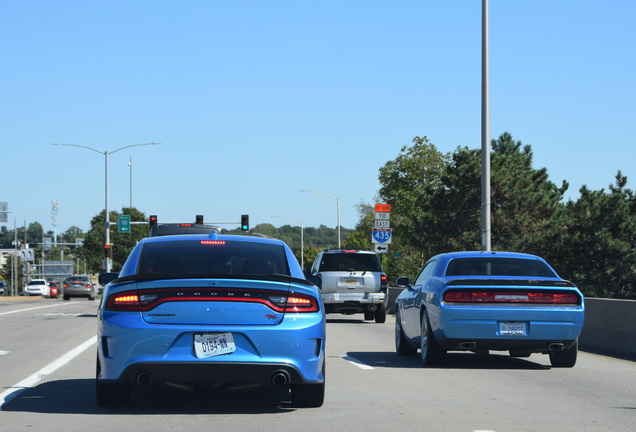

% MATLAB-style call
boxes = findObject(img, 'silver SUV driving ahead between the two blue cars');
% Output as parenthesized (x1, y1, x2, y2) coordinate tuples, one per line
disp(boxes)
(308, 250, 388, 323)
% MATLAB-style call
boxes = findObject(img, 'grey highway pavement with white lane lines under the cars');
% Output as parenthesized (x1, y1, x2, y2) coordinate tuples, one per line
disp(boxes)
(0, 299, 636, 432)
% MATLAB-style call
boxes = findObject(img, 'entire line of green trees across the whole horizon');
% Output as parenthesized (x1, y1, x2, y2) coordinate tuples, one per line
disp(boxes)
(0, 132, 636, 299)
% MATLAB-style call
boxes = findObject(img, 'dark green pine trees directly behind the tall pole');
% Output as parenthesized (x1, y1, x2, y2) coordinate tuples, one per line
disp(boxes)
(430, 132, 568, 256)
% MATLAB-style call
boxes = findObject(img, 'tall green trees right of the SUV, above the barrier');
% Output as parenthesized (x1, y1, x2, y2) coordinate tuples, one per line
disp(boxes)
(356, 132, 636, 299)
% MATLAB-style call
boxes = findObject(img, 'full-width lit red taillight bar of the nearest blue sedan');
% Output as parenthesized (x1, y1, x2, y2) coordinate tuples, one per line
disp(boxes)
(106, 288, 320, 313)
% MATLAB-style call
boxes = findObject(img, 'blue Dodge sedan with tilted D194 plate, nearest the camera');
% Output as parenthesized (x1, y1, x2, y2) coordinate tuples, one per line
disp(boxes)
(96, 232, 326, 407)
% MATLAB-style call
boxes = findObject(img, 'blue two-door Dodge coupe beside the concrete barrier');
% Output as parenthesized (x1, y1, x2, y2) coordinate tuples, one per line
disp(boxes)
(395, 252, 584, 367)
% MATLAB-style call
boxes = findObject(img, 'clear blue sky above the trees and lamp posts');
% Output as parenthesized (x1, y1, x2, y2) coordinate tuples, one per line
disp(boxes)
(0, 0, 636, 233)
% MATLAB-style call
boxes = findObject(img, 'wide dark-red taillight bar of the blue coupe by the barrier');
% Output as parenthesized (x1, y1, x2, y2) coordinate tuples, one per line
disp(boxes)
(444, 290, 580, 305)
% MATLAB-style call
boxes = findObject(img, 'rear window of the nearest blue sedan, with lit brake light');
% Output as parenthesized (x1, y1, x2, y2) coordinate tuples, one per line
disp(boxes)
(137, 240, 290, 276)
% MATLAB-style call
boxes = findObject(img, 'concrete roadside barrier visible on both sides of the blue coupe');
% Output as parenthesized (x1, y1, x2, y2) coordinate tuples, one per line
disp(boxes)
(387, 288, 636, 360)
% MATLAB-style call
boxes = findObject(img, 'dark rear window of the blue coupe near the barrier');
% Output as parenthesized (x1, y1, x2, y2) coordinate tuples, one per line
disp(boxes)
(446, 257, 556, 277)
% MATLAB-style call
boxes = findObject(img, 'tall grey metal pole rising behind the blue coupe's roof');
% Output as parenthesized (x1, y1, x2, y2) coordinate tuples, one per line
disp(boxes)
(481, 0, 491, 252)
